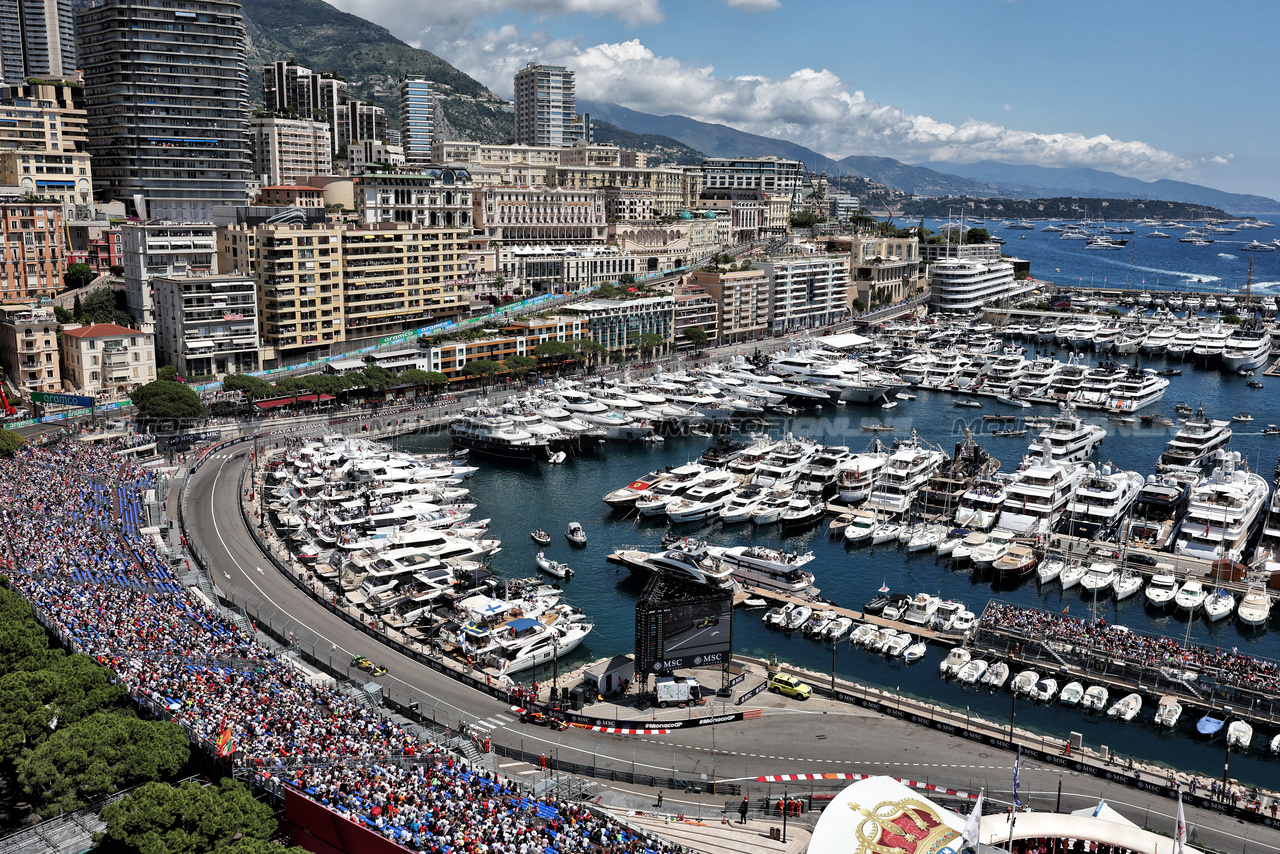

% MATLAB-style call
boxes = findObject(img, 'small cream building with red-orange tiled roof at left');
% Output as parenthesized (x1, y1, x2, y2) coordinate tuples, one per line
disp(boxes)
(63, 323, 156, 399)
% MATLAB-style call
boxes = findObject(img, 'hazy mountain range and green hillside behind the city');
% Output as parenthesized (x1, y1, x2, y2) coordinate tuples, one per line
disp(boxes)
(232, 0, 1280, 214)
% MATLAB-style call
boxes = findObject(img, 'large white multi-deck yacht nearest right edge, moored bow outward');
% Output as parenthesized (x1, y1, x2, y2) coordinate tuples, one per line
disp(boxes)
(1176, 451, 1270, 561)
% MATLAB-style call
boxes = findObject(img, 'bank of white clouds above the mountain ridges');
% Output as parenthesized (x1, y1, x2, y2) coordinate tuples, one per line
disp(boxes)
(327, 0, 1217, 178)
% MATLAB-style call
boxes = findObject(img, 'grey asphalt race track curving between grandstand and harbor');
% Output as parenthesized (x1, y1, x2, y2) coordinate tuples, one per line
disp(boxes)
(187, 446, 1280, 854)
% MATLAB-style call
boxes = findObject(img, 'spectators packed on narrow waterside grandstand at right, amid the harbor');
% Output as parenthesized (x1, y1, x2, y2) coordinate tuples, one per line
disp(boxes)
(980, 603, 1280, 695)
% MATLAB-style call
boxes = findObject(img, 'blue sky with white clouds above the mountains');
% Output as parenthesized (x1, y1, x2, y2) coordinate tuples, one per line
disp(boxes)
(329, 0, 1280, 198)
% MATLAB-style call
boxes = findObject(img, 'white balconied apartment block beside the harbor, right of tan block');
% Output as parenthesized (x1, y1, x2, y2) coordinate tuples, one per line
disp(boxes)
(759, 255, 850, 335)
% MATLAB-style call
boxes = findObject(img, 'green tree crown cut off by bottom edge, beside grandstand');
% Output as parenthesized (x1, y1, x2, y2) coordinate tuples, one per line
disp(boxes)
(99, 777, 302, 854)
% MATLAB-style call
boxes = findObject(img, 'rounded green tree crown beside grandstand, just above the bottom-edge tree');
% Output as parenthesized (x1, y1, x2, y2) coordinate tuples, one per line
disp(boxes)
(15, 712, 191, 818)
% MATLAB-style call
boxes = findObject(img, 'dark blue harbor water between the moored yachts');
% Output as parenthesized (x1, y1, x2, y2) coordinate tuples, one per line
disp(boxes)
(399, 344, 1280, 782)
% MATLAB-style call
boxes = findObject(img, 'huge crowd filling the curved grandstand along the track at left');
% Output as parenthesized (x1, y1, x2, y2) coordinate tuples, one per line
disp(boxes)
(0, 440, 675, 854)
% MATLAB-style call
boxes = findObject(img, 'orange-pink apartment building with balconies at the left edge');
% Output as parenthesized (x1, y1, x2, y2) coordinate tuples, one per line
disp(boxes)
(0, 196, 67, 301)
